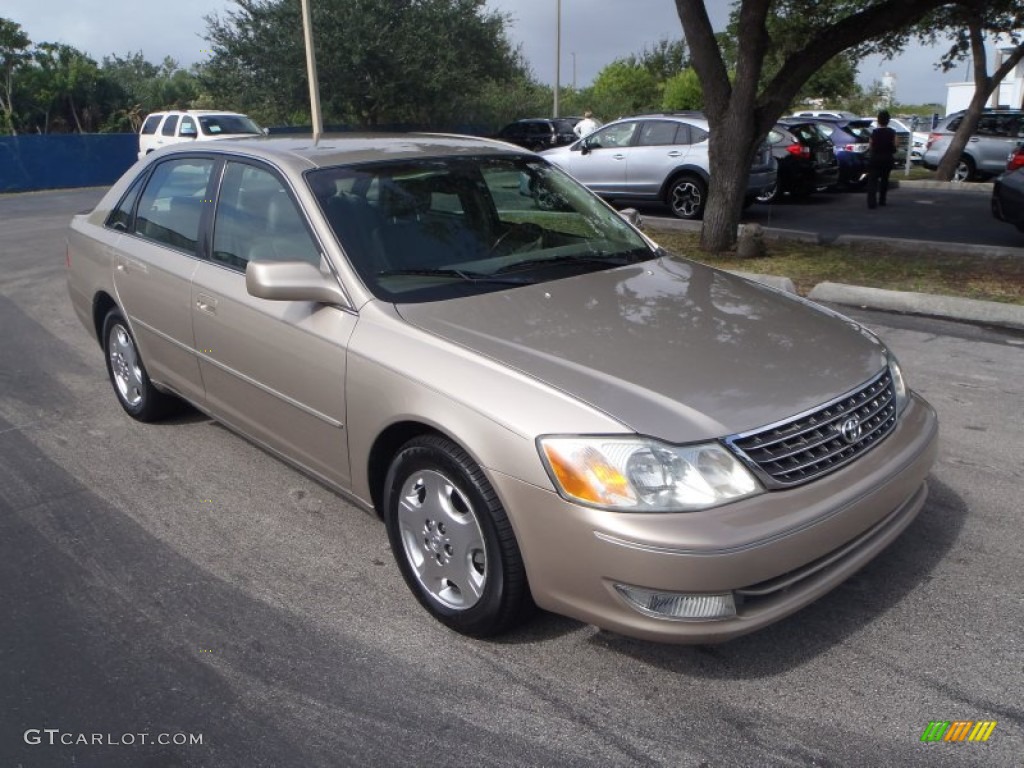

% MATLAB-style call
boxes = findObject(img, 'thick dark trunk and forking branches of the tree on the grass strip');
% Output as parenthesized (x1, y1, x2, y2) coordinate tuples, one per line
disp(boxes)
(676, 0, 947, 252)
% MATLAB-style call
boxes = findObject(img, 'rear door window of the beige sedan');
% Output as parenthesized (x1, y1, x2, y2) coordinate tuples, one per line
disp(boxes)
(135, 158, 214, 254)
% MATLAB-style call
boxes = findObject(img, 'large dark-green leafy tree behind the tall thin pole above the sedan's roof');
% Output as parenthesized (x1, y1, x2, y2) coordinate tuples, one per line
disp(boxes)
(203, 0, 525, 127)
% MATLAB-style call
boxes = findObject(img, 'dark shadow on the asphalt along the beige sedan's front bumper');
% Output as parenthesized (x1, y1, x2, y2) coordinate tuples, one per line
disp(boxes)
(590, 476, 969, 679)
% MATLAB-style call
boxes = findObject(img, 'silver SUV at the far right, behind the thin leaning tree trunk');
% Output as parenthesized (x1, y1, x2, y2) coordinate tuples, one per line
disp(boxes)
(924, 110, 1024, 181)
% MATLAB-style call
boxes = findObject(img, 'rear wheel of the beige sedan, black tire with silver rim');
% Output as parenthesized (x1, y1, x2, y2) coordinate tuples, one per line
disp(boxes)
(102, 309, 175, 422)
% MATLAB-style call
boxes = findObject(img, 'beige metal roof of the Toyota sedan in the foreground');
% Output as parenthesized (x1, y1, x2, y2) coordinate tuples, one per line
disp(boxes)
(153, 133, 522, 172)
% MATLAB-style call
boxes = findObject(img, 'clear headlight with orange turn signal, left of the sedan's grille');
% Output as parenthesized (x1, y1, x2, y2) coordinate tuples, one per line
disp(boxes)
(538, 436, 761, 512)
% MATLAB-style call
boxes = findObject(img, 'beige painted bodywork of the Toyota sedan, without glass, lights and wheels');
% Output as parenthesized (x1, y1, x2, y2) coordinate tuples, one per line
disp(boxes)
(69, 135, 938, 642)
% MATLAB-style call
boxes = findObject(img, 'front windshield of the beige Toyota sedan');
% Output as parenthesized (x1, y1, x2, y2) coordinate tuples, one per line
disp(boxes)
(306, 155, 656, 303)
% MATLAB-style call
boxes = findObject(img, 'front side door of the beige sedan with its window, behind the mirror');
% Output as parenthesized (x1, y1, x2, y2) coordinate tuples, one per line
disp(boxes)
(191, 161, 356, 485)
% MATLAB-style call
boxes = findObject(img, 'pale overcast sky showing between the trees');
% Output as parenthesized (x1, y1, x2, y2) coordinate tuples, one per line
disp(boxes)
(8, 0, 967, 109)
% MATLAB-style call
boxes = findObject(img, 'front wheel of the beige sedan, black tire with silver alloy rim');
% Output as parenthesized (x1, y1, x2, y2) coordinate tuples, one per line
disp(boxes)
(384, 435, 534, 637)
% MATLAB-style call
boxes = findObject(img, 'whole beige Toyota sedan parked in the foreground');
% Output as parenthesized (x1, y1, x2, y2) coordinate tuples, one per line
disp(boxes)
(68, 135, 938, 642)
